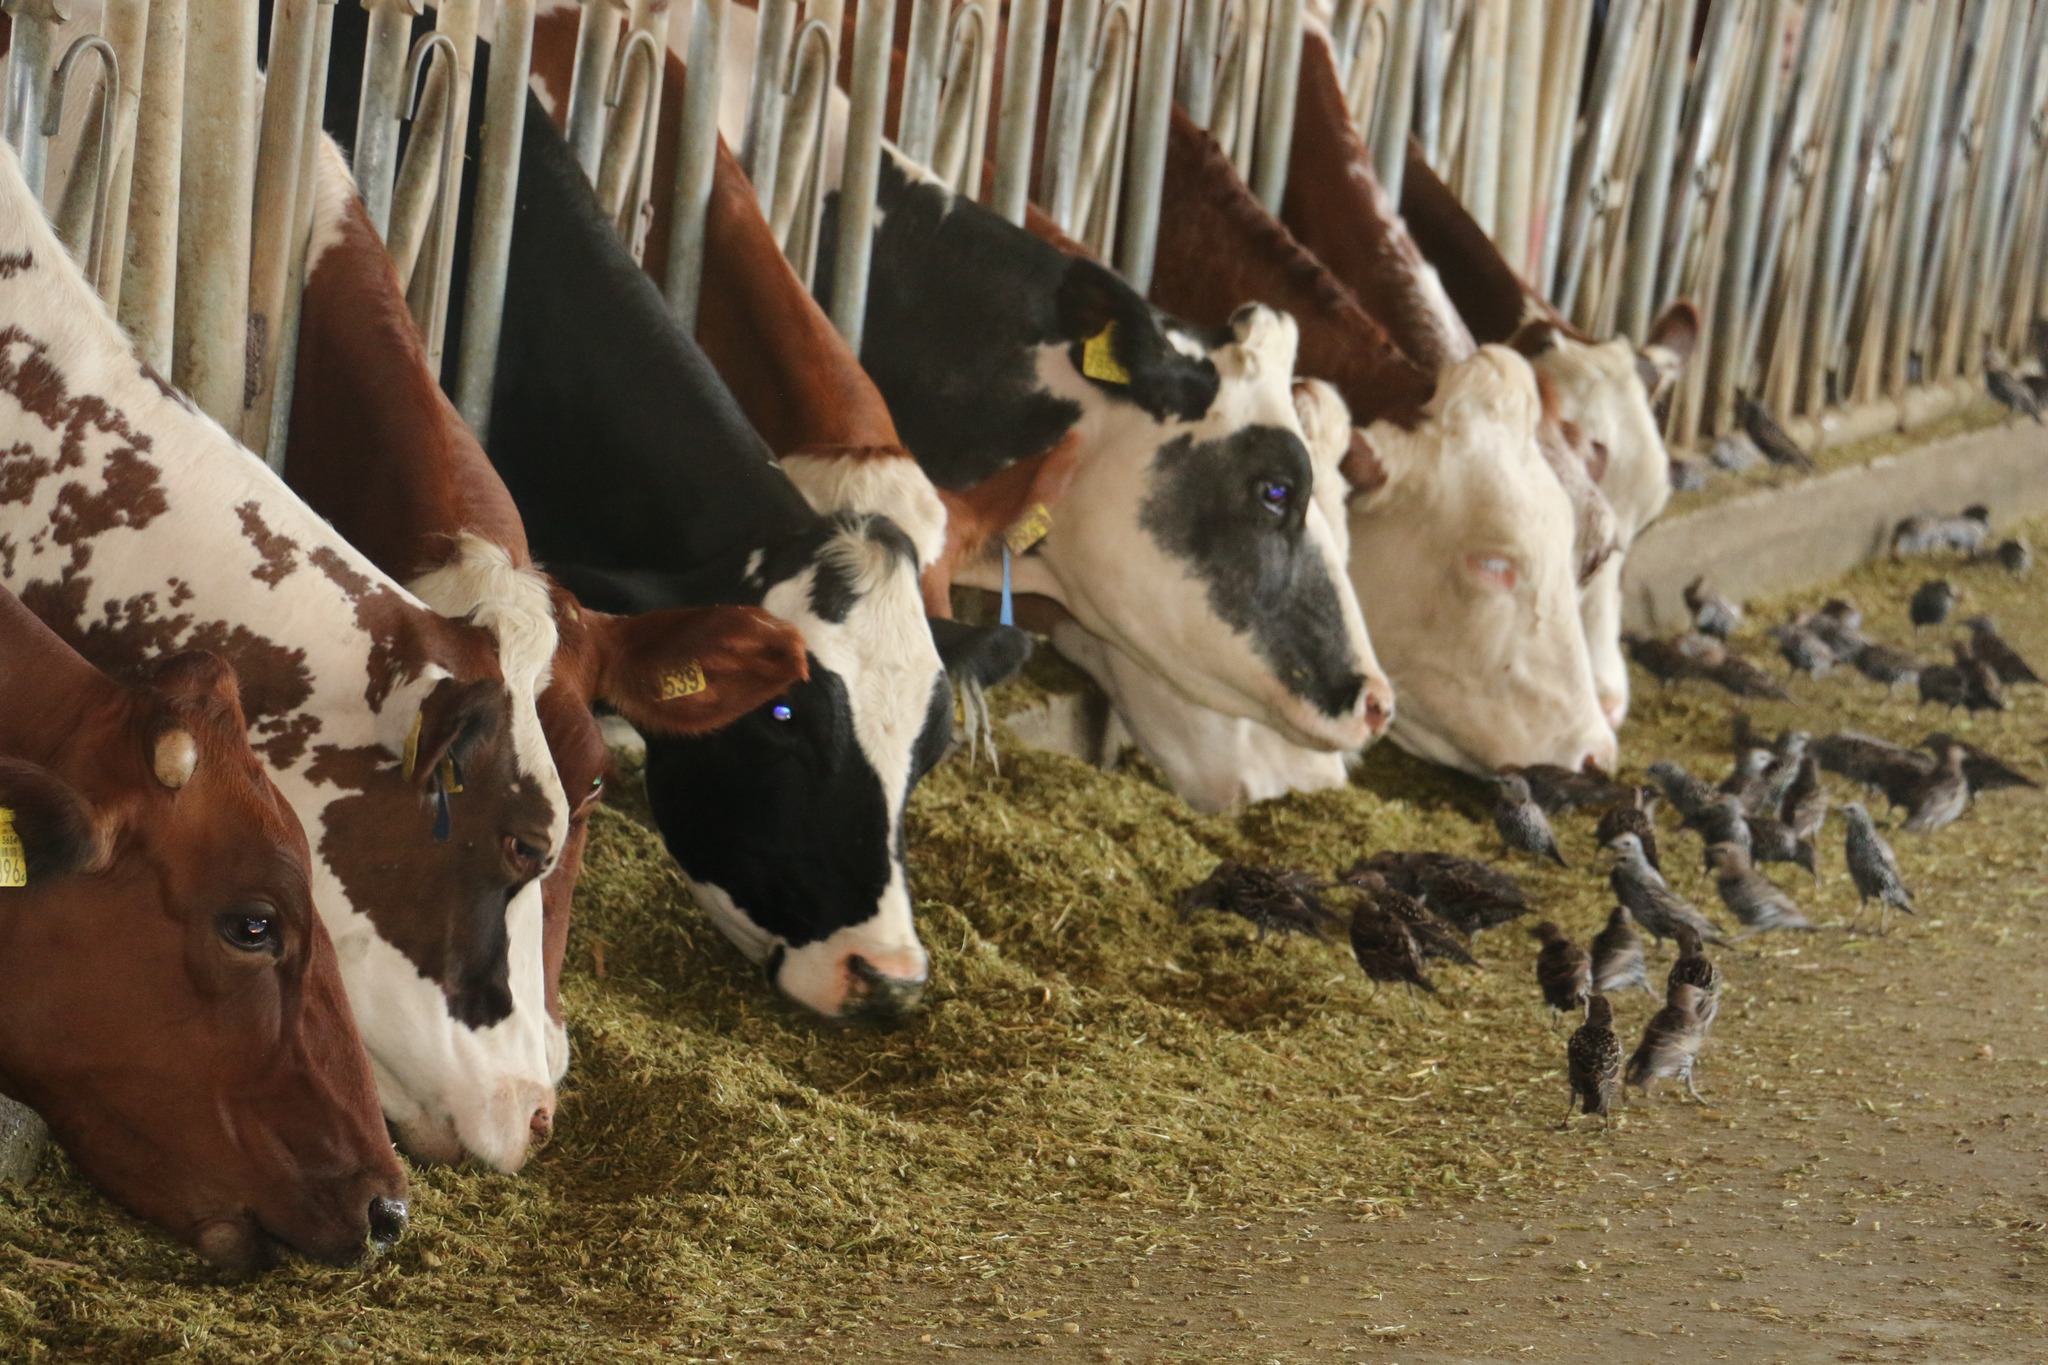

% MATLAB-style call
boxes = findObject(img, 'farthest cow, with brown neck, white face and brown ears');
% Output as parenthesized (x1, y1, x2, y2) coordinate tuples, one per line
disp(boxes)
(1392, 144, 1700, 726)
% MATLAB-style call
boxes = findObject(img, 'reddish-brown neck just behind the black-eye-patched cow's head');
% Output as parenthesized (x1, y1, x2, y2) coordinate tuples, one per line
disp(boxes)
(1153, 106, 1436, 428)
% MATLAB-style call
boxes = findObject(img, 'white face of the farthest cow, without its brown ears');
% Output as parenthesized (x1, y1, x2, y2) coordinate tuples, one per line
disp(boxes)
(1534, 336, 1671, 726)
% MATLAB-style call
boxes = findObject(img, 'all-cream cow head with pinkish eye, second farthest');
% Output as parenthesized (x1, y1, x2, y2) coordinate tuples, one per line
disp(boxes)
(1346, 346, 1616, 772)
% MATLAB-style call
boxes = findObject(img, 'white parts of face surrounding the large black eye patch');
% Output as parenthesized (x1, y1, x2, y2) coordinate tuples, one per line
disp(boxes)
(954, 307, 1391, 751)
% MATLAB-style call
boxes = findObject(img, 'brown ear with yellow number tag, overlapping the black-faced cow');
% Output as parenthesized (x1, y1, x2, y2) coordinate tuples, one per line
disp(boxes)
(584, 606, 811, 735)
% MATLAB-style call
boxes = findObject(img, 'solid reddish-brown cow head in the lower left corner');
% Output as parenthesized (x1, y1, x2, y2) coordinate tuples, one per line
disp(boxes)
(0, 587, 406, 1269)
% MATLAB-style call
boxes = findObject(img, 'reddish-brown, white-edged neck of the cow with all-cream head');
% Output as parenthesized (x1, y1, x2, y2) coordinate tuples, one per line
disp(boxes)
(1280, 33, 1477, 370)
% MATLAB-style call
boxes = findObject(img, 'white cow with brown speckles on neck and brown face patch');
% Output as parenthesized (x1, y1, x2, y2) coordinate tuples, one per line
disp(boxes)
(0, 139, 569, 1171)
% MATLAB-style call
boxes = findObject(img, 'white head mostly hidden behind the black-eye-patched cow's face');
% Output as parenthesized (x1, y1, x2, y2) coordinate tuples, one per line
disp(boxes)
(1053, 379, 1352, 810)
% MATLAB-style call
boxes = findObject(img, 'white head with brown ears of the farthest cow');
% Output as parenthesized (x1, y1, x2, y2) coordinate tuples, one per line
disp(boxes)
(1511, 299, 1700, 729)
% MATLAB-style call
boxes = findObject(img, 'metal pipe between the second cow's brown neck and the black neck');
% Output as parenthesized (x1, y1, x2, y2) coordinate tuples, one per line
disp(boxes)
(455, 0, 536, 442)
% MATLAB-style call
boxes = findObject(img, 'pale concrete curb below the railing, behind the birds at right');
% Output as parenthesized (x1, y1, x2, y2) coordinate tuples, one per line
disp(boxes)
(1622, 422, 2048, 634)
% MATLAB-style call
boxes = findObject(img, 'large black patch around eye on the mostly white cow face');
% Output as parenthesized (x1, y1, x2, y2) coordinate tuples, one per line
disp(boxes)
(1139, 426, 1364, 716)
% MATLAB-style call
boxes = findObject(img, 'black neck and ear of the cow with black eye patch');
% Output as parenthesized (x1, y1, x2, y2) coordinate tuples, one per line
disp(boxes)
(813, 156, 1219, 489)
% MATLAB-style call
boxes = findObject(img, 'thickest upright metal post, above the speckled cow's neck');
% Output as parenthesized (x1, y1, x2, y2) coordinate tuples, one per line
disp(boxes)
(170, 0, 256, 432)
